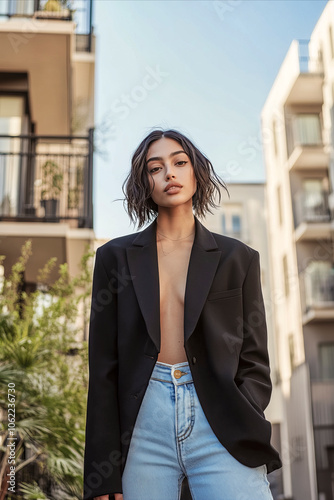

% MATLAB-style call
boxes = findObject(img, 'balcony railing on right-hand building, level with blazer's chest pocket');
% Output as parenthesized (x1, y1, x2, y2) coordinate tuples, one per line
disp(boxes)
(300, 260, 334, 313)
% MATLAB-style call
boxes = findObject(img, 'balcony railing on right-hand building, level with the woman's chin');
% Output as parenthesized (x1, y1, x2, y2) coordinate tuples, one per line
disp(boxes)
(293, 191, 330, 228)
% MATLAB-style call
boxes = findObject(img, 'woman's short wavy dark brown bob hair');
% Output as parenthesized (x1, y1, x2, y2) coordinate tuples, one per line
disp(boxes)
(122, 128, 230, 229)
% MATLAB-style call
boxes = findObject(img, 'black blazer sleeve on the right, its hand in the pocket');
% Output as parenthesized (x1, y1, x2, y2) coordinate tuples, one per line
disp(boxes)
(235, 250, 272, 415)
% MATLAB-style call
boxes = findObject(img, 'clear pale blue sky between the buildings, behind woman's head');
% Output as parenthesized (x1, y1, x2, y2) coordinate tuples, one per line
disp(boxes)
(93, 0, 327, 239)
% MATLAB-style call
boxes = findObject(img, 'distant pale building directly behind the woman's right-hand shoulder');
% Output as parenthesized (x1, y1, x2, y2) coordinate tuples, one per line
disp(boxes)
(205, 183, 283, 500)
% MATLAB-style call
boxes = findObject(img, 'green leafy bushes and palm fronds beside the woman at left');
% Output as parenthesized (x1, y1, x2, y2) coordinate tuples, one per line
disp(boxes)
(0, 240, 94, 500)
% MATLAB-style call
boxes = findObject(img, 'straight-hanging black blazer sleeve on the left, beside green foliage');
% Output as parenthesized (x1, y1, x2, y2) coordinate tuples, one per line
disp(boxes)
(83, 248, 122, 500)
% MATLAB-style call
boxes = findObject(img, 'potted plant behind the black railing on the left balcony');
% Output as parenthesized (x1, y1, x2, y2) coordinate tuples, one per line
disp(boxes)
(41, 160, 64, 217)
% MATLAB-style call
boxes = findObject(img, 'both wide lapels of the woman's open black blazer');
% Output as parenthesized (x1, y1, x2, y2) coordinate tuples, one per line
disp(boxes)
(126, 216, 221, 352)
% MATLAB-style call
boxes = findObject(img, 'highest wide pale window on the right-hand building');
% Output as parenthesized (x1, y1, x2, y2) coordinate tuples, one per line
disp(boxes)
(293, 113, 322, 146)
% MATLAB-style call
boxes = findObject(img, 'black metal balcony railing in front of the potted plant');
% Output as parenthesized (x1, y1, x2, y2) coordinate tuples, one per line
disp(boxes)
(0, 129, 94, 228)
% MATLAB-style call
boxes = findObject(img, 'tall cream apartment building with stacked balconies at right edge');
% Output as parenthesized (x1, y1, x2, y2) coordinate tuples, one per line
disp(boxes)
(261, 0, 334, 500)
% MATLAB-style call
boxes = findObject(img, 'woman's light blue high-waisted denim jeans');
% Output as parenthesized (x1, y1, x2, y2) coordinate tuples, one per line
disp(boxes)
(122, 361, 273, 500)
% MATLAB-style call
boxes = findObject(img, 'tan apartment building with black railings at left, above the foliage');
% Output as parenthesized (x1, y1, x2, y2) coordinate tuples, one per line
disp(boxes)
(0, 0, 95, 336)
